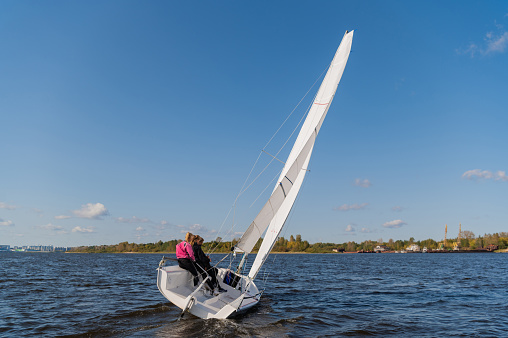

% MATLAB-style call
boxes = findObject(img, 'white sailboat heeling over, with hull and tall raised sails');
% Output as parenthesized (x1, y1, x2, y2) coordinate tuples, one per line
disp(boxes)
(157, 31, 353, 319)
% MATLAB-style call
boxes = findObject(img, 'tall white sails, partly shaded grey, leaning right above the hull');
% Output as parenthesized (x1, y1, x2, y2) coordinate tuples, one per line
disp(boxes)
(236, 31, 353, 279)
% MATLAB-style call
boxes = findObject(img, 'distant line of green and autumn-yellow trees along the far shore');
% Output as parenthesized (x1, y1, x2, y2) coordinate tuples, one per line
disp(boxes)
(71, 230, 508, 253)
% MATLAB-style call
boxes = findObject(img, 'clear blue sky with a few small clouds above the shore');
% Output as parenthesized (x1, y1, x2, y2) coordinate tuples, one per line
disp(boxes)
(0, 1, 508, 246)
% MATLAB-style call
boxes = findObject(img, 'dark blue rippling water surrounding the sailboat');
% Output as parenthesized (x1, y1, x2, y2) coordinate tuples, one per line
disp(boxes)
(0, 252, 508, 337)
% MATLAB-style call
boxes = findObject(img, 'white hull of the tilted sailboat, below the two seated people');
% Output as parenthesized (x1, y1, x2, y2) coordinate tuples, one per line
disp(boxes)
(157, 265, 261, 319)
